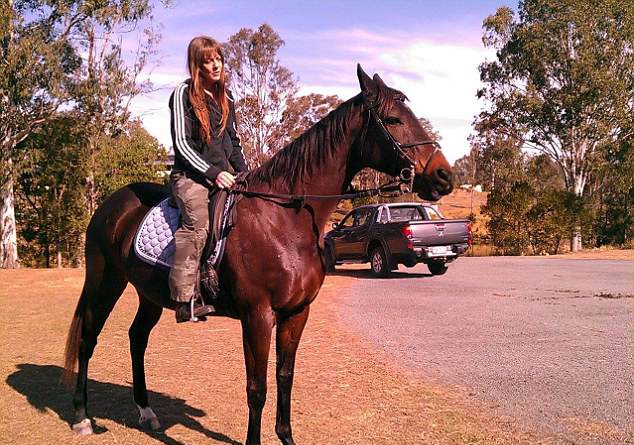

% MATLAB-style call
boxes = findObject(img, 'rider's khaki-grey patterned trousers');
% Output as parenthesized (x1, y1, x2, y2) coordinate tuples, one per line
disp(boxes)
(169, 173, 209, 302)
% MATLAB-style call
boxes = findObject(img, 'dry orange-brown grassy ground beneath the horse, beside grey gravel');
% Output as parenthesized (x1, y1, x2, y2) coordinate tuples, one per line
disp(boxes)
(0, 269, 564, 445)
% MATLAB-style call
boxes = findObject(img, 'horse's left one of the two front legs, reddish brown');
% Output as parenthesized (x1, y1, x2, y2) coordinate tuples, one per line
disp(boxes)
(242, 307, 275, 445)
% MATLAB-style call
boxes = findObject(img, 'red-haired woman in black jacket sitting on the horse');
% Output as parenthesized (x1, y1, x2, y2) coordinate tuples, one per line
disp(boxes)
(169, 36, 247, 323)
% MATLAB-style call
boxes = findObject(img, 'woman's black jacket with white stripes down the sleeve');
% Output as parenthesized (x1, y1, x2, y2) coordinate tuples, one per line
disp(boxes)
(169, 79, 247, 181)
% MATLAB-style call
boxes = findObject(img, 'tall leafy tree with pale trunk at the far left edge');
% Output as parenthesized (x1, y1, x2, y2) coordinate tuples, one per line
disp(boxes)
(0, 0, 80, 268)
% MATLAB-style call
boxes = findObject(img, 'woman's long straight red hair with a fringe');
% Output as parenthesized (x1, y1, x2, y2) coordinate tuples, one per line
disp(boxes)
(187, 36, 229, 143)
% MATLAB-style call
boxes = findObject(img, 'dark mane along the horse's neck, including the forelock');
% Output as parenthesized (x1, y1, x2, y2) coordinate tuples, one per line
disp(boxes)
(246, 87, 405, 192)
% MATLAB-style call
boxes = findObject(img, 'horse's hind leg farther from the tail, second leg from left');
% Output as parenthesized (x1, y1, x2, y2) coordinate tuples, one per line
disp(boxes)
(128, 294, 163, 431)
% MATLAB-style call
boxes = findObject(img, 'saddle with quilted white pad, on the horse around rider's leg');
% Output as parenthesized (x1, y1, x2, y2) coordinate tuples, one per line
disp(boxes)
(134, 189, 238, 299)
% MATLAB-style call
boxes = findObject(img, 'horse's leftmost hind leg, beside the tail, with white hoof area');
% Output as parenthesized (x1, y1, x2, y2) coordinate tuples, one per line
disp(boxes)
(67, 253, 128, 435)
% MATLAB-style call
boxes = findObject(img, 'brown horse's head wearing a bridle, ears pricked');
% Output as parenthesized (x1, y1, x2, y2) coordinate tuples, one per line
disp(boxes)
(357, 65, 453, 201)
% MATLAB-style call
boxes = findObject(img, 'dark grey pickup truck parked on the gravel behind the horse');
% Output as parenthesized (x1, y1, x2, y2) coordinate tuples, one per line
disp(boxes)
(324, 203, 471, 277)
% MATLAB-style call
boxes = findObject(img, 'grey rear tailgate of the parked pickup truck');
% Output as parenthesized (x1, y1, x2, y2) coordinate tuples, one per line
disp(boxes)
(409, 219, 469, 246)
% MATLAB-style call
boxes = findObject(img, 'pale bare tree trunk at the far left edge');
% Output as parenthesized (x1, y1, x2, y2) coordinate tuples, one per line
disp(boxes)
(0, 159, 19, 269)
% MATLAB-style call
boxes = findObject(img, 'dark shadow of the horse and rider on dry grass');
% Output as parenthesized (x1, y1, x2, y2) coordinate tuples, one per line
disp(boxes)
(7, 363, 241, 445)
